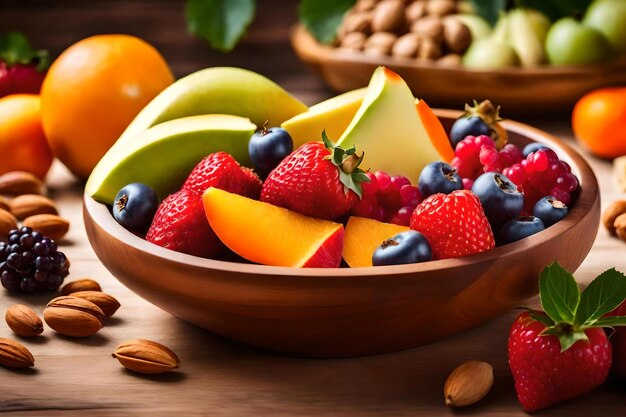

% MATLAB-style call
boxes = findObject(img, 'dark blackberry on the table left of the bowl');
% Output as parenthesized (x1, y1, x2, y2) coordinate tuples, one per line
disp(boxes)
(0, 227, 70, 293)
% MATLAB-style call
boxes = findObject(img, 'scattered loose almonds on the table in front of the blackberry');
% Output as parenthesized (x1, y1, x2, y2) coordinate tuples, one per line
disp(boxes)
(0, 268, 180, 374)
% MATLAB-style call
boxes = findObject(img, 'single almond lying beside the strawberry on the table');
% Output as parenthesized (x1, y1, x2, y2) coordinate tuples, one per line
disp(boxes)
(443, 361, 493, 407)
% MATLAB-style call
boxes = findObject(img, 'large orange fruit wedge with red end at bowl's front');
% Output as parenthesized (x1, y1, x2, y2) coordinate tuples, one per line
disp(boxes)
(202, 187, 344, 268)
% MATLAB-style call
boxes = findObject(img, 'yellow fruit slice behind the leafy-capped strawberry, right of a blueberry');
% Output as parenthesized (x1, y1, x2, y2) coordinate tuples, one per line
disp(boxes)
(281, 88, 367, 149)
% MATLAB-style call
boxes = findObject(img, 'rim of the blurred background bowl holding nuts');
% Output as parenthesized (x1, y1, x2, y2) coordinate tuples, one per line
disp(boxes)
(291, 23, 626, 78)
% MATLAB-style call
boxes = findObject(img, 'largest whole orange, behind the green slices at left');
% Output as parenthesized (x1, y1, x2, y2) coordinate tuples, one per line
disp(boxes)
(41, 35, 174, 179)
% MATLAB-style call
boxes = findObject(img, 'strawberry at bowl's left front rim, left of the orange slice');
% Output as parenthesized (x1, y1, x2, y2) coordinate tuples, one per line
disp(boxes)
(146, 189, 223, 258)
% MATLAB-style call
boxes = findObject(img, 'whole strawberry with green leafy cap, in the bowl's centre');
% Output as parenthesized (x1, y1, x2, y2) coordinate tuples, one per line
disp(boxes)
(261, 132, 369, 220)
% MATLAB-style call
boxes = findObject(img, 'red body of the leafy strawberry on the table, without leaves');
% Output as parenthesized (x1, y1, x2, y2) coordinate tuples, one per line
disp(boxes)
(508, 312, 611, 412)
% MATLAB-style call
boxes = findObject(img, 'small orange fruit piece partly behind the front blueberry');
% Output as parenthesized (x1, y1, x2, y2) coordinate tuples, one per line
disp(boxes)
(343, 217, 409, 268)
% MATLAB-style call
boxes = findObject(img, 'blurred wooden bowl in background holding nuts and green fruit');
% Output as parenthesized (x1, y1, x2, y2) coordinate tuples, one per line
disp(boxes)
(291, 25, 626, 116)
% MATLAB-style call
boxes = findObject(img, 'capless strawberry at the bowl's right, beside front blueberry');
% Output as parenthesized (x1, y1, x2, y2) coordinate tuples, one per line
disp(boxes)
(411, 190, 496, 259)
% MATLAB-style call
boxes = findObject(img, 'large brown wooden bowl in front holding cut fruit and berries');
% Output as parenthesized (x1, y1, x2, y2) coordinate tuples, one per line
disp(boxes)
(83, 110, 600, 357)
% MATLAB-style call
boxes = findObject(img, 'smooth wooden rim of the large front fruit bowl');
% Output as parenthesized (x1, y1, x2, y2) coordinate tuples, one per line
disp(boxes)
(83, 109, 600, 280)
